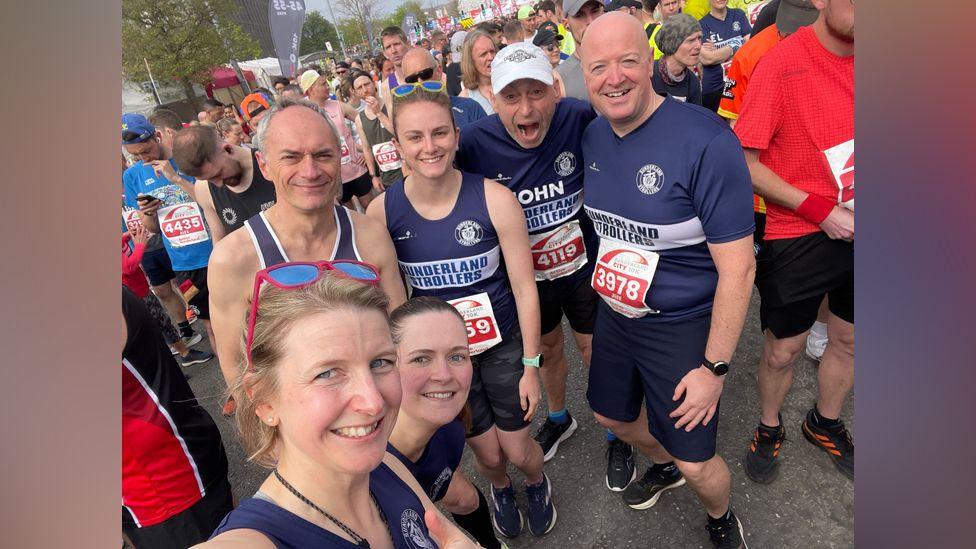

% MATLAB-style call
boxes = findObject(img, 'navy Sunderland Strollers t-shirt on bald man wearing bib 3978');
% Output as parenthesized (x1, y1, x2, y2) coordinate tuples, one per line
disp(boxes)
(583, 97, 755, 322)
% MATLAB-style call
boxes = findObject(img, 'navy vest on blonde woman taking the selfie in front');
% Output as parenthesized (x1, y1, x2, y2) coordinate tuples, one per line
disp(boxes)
(211, 463, 437, 549)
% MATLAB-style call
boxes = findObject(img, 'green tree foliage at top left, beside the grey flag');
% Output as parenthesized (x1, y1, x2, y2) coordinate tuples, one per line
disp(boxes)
(122, 0, 261, 82)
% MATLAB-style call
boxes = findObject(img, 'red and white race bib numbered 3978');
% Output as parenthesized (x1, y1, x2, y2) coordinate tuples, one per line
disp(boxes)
(590, 239, 659, 318)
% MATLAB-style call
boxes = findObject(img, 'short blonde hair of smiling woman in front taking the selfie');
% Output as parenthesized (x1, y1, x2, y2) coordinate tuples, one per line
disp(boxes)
(232, 273, 389, 467)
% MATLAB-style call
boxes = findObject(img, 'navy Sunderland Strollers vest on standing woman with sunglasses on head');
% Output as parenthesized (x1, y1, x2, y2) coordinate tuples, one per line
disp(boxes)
(385, 172, 516, 336)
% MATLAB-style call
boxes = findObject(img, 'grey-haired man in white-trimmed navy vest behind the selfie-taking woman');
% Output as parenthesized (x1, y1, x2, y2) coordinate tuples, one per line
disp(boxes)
(209, 99, 406, 413)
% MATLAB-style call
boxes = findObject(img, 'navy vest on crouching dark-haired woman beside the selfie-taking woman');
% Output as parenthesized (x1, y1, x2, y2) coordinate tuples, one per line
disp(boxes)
(386, 419, 465, 502)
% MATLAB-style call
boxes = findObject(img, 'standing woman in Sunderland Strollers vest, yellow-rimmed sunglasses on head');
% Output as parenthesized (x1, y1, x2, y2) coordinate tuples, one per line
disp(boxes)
(366, 82, 556, 537)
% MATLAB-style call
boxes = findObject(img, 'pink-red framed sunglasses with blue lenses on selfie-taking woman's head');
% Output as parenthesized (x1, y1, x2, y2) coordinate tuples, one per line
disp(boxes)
(244, 259, 380, 370)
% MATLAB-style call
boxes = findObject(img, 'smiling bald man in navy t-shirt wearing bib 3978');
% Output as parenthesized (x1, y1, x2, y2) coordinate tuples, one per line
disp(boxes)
(582, 12, 755, 548)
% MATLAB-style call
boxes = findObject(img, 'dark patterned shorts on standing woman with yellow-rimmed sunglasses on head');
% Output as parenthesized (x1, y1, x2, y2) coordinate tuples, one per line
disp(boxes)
(466, 324, 530, 438)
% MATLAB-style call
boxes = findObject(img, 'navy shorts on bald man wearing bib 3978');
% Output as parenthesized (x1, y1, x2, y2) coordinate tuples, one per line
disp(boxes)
(586, 301, 719, 462)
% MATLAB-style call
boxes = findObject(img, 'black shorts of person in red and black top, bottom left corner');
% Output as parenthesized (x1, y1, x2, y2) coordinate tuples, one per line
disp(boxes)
(122, 477, 234, 549)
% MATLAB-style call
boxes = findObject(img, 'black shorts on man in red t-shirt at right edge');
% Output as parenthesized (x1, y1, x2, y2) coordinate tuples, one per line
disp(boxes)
(756, 232, 854, 339)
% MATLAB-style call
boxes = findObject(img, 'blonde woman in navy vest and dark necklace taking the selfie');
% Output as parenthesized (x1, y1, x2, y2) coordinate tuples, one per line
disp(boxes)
(204, 272, 475, 549)
